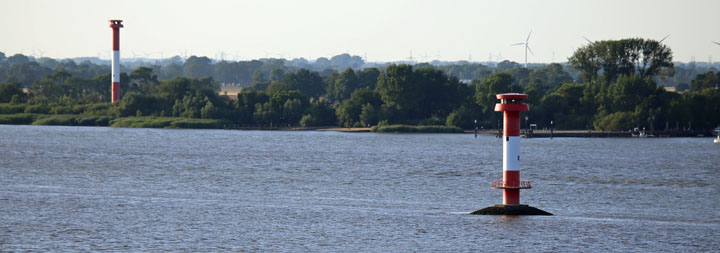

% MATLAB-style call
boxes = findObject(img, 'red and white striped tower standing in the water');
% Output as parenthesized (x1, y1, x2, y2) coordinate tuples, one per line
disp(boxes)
(492, 93, 531, 205)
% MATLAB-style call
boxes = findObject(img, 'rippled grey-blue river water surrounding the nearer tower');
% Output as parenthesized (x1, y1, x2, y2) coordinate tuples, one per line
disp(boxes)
(0, 125, 720, 252)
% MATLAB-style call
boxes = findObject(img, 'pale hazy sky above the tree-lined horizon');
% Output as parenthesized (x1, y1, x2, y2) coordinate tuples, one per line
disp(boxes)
(0, 0, 720, 63)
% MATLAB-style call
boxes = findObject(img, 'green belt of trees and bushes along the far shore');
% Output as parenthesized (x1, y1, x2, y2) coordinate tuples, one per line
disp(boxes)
(0, 38, 720, 133)
